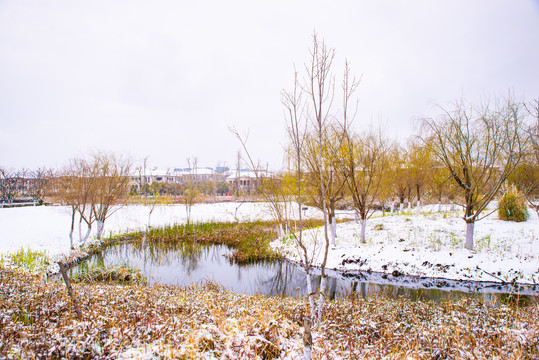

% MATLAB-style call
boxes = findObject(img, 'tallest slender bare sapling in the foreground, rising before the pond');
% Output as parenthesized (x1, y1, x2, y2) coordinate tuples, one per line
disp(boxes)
(301, 33, 359, 322)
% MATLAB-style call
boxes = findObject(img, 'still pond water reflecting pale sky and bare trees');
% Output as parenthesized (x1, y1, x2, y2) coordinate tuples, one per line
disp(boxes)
(78, 242, 539, 303)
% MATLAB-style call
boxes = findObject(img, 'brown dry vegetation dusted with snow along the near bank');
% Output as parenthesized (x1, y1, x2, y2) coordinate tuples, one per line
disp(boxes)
(0, 267, 539, 359)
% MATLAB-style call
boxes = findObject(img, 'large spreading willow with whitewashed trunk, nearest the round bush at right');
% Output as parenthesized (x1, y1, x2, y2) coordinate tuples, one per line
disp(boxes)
(423, 98, 528, 250)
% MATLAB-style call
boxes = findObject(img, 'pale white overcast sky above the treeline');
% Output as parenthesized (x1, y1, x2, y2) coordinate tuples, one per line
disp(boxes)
(0, 0, 539, 172)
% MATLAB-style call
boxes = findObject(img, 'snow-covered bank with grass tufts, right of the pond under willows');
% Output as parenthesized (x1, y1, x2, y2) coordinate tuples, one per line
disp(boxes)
(273, 206, 539, 284)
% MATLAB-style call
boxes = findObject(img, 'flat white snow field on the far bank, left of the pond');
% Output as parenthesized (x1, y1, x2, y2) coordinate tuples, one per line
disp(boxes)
(0, 202, 278, 255)
